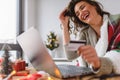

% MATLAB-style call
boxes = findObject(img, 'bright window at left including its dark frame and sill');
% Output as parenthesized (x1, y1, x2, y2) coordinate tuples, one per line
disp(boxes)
(0, 0, 21, 60)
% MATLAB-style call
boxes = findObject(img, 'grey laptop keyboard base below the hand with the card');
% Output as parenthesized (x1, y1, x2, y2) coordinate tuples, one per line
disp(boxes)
(57, 64, 92, 77)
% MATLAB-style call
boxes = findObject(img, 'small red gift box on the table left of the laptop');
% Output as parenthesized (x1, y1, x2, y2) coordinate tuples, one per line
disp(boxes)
(13, 60, 26, 71)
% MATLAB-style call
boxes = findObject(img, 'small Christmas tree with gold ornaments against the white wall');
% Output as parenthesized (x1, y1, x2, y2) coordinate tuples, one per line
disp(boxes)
(46, 31, 59, 50)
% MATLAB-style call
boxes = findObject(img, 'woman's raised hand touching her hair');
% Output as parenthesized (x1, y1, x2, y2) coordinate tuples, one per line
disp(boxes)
(59, 9, 69, 29)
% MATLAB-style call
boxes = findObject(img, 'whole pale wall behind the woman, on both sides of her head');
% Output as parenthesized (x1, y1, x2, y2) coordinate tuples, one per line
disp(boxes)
(25, 0, 120, 57)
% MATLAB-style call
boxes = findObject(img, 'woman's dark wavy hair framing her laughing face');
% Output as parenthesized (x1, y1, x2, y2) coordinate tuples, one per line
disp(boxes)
(66, 0, 109, 31)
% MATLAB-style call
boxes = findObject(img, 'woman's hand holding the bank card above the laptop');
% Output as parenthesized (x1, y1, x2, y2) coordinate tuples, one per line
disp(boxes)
(78, 45, 100, 70)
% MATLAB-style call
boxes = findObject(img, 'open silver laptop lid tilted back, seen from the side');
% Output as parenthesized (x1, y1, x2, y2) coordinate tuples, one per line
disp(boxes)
(17, 27, 62, 78)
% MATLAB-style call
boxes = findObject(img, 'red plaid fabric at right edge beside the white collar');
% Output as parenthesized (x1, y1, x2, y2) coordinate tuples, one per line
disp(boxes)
(107, 21, 120, 52)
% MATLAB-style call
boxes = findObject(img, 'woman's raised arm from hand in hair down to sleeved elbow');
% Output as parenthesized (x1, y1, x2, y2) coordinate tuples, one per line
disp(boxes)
(59, 9, 78, 60)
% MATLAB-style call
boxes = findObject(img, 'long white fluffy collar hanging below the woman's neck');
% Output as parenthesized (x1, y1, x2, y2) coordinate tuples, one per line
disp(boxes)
(95, 15, 108, 56)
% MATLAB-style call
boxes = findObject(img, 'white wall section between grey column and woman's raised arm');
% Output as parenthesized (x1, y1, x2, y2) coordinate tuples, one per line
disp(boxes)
(37, 0, 69, 57)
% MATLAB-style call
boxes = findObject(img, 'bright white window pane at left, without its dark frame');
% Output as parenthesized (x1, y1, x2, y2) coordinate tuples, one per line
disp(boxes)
(0, 0, 17, 43)
